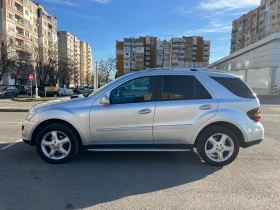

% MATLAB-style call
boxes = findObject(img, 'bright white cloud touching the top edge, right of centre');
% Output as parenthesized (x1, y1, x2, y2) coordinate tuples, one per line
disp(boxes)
(199, 0, 260, 10)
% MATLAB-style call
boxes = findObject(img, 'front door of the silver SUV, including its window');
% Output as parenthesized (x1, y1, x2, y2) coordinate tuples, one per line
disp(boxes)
(90, 76, 160, 144)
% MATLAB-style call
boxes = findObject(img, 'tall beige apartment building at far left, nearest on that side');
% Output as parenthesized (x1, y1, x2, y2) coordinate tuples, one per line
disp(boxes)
(0, 0, 57, 85)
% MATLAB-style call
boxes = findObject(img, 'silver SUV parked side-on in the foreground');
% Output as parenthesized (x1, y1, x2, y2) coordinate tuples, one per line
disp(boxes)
(22, 69, 264, 166)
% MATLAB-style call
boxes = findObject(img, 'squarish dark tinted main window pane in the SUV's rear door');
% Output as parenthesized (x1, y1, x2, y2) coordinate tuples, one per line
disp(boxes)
(162, 75, 194, 100)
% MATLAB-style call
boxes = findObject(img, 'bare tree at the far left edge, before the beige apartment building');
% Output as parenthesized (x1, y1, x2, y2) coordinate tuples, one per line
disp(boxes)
(0, 34, 17, 81)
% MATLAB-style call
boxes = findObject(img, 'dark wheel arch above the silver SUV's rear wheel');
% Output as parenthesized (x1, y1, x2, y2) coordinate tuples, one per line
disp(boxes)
(193, 121, 245, 147)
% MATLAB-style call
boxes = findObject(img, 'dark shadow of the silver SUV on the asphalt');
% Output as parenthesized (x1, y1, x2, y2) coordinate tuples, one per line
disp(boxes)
(0, 143, 222, 209)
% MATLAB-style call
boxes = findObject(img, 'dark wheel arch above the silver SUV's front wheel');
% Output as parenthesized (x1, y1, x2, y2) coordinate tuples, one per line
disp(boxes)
(31, 119, 83, 148)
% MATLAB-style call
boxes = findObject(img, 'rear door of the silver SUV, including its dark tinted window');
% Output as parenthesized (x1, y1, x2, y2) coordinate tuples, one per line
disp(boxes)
(153, 75, 218, 144)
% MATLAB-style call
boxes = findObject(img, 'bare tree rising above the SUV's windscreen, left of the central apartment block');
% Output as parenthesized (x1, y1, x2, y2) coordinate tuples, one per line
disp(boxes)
(98, 57, 116, 82)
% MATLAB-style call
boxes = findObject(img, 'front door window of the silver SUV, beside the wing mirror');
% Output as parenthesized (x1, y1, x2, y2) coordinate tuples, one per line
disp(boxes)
(110, 76, 156, 104)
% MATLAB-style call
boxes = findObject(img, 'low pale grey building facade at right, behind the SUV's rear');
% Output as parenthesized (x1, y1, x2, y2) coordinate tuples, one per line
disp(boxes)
(209, 33, 280, 95)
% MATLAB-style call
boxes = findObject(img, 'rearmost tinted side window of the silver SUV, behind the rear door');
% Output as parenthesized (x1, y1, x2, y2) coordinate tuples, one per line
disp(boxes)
(211, 77, 256, 98)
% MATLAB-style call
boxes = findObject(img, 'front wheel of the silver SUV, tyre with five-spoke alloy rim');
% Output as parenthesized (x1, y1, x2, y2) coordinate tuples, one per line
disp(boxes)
(36, 123, 79, 164)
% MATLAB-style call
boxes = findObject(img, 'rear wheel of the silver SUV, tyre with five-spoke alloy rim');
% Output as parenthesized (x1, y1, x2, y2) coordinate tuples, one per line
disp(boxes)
(196, 126, 240, 166)
